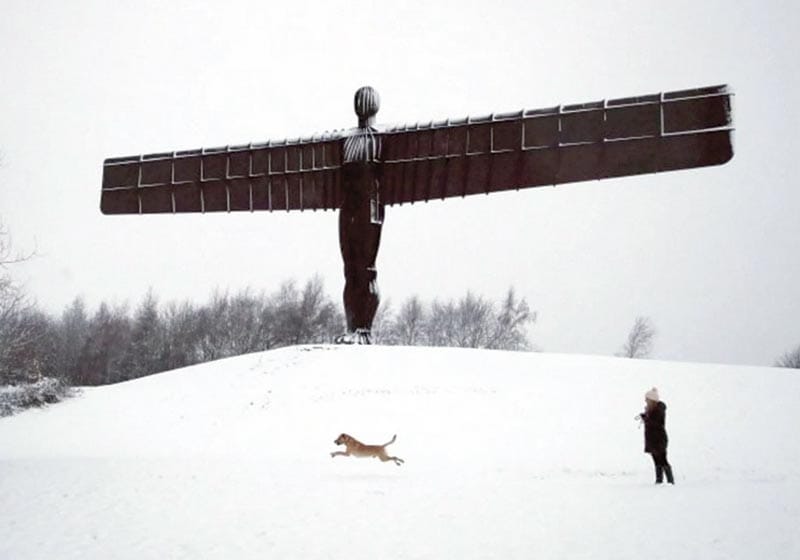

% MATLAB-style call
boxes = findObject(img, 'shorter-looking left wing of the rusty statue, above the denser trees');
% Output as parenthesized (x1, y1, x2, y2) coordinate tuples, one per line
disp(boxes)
(100, 133, 341, 214)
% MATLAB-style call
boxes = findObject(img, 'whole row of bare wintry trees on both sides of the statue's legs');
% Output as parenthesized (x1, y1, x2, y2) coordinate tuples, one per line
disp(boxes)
(0, 277, 536, 386)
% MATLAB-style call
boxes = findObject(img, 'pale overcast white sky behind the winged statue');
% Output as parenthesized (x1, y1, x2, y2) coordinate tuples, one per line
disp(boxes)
(0, 0, 800, 365)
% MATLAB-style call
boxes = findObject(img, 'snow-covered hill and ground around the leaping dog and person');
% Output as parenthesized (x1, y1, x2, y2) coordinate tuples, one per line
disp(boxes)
(0, 346, 800, 560)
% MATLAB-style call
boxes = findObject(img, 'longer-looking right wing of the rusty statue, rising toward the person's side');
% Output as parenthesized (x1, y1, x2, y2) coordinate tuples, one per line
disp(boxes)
(381, 86, 733, 204)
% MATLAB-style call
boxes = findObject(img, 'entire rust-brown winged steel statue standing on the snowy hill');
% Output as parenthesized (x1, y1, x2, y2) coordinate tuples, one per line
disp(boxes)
(101, 86, 733, 343)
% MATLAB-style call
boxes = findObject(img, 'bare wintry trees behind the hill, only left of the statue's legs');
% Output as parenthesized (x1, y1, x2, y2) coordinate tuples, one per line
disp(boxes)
(0, 278, 342, 385)
